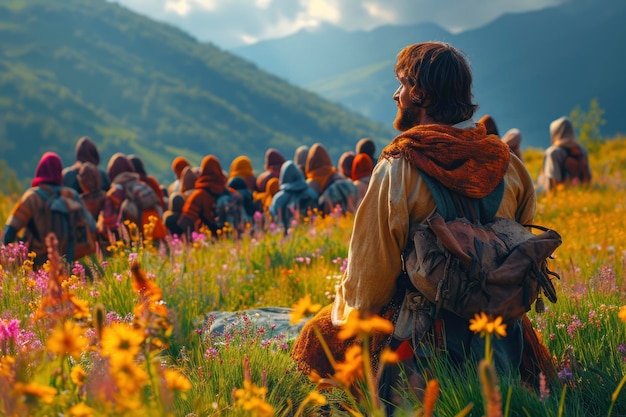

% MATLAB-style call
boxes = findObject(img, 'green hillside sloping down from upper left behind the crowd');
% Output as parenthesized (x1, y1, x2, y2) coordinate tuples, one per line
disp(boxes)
(0, 0, 393, 185)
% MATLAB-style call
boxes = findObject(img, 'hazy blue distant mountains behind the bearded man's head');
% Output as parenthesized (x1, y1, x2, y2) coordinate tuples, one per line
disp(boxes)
(233, 0, 626, 149)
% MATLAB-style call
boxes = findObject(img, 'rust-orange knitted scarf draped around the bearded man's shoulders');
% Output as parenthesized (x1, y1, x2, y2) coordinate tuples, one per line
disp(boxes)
(380, 123, 510, 198)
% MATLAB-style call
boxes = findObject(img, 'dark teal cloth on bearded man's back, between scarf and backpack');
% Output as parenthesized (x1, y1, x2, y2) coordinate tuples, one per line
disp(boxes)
(420, 171, 504, 223)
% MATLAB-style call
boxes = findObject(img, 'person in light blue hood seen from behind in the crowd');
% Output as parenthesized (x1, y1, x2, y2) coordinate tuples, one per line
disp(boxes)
(269, 161, 319, 233)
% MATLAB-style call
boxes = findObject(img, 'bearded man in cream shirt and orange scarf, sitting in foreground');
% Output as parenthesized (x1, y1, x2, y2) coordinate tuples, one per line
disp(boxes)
(331, 42, 536, 413)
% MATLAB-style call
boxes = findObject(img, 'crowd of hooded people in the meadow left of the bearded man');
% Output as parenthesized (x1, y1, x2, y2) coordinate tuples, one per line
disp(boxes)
(2, 137, 376, 265)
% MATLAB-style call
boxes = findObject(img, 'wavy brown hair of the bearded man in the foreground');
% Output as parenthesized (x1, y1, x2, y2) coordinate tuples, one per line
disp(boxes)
(394, 42, 478, 125)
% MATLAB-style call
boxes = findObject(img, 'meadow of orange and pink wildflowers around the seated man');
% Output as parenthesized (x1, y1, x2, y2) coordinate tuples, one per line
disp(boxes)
(0, 138, 626, 417)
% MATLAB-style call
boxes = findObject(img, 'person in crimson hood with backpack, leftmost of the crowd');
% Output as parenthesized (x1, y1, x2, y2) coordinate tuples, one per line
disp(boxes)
(2, 152, 95, 266)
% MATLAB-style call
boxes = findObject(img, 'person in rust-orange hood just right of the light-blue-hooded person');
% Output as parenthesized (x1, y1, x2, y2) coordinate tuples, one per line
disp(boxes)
(306, 143, 359, 214)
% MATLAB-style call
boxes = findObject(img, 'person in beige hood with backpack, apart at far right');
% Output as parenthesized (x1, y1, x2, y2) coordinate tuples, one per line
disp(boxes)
(537, 116, 591, 191)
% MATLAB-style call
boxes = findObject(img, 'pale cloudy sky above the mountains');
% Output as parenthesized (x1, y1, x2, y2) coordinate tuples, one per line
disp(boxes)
(111, 0, 565, 49)
